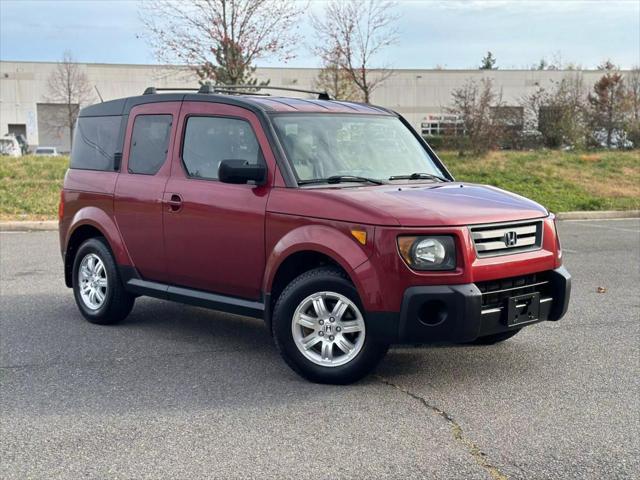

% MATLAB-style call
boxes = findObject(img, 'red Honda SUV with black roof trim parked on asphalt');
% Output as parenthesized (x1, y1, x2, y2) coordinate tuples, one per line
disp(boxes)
(59, 87, 570, 383)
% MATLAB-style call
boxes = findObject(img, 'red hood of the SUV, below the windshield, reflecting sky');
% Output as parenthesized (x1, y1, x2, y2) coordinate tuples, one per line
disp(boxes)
(269, 182, 548, 227)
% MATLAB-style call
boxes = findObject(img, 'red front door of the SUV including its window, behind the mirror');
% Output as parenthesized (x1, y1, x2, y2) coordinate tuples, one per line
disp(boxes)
(164, 102, 275, 299)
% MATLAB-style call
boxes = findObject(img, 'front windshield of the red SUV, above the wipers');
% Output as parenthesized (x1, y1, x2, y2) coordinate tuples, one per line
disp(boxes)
(273, 114, 445, 182)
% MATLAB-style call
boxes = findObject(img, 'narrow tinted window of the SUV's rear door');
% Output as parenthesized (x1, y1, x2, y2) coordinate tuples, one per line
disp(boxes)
(129, 115, 172, 175)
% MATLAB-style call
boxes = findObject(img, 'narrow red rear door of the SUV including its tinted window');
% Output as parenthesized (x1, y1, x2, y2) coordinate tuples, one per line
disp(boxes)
(114, 102, 181, 282)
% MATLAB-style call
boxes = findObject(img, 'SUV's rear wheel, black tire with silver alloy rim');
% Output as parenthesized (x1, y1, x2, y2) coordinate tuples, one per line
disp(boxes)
(72, 237, 135, 325)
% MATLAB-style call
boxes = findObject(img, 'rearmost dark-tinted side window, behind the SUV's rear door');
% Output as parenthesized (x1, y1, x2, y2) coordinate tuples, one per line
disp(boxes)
(70, 116, 122, 171)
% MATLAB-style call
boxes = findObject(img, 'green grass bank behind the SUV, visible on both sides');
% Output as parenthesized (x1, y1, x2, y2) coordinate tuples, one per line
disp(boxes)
(0, 150, 640, 220)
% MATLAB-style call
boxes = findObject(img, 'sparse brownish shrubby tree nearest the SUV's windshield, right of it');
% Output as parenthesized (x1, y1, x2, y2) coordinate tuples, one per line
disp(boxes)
(447, 78, 503, 153)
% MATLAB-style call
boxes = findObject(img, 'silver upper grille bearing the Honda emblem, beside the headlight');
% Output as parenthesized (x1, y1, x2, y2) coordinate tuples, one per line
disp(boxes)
(469, 220, 542, 257)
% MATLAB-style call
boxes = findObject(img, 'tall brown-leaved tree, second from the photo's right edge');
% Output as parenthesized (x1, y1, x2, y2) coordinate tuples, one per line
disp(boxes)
(588, 60, 627, 148)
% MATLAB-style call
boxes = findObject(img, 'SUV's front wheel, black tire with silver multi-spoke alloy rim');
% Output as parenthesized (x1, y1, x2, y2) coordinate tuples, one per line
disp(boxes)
(272, 267, 389, 385)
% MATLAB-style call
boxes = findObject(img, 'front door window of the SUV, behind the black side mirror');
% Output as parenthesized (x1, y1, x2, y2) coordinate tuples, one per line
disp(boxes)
(182, 117, 262, 180)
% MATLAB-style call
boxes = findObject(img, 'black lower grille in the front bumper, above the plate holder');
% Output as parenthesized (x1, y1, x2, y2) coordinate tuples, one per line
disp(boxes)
(476, 272, 551, 310)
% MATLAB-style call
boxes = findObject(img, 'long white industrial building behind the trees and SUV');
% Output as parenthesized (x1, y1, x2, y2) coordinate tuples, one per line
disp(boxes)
(0, 61, 620, 152)
